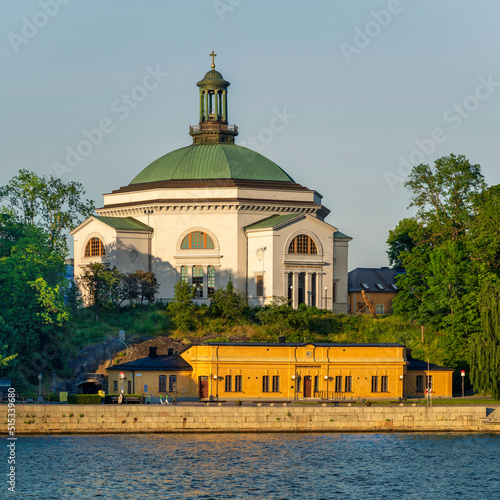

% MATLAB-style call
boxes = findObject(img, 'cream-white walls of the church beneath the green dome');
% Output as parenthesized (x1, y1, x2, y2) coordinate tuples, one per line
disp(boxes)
(72, 181, 350, 312)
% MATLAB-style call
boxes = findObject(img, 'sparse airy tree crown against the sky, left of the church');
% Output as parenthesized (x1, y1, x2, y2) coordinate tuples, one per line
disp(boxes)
(0, 170, 95, 253)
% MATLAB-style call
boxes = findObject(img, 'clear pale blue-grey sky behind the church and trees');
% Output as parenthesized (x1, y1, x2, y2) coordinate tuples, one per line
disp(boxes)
(0, 0, 500, 269)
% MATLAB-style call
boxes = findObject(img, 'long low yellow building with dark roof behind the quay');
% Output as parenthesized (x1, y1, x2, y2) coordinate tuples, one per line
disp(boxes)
(108, 342, 453, 401)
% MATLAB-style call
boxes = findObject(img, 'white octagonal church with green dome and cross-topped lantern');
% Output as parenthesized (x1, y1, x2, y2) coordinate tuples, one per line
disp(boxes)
(71, 52, 351, 313)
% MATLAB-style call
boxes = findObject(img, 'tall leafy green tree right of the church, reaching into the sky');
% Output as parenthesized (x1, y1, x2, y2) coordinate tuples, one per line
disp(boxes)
(388, 155, 500, 372)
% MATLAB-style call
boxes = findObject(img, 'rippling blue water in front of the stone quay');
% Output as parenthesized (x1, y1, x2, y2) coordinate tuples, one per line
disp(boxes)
(0, 433, 500, 500)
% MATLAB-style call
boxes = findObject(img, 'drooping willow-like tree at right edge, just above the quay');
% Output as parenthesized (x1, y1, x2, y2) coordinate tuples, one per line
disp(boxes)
(470, 276, 500, 399)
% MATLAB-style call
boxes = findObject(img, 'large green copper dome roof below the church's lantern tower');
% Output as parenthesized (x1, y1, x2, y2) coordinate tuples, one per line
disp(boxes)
(130, 144, 294, 185)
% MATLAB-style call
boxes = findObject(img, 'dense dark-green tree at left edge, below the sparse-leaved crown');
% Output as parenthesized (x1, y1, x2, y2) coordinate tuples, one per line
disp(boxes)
(0, 227, 68, 383)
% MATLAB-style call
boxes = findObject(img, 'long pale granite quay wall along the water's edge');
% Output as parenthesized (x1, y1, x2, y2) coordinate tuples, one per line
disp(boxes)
(0, 403, 500, 435)
